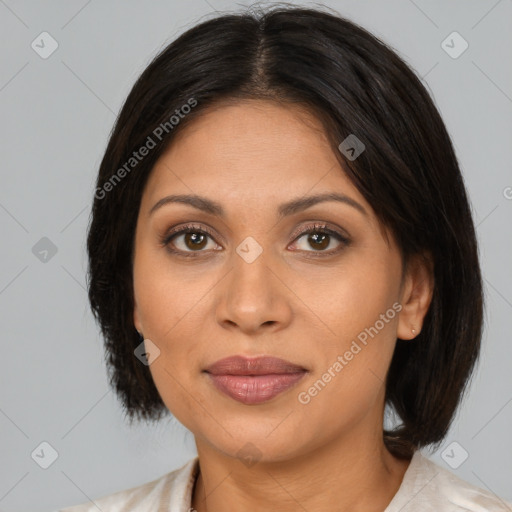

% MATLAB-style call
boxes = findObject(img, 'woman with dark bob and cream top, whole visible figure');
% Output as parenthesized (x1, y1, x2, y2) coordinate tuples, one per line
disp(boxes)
(61, 7, 512, 512)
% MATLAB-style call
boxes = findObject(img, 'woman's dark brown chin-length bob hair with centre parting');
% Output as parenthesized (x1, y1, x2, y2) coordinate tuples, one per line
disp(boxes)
(87, 4, 483, 458)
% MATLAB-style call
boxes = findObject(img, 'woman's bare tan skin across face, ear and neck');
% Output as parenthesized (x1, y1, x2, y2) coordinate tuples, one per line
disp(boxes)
(133, 100, 433, 512)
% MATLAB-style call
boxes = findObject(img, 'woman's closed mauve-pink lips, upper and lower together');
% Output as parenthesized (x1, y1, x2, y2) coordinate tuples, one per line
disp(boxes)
(204, 356, 307, 405)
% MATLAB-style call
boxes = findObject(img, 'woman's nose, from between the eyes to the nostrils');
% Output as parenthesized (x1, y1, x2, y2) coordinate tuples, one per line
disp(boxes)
(216, 244, 293, 335)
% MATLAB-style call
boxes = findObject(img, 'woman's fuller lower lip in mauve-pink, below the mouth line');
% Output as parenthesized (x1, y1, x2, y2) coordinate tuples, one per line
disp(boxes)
(208, 372, 306, 405)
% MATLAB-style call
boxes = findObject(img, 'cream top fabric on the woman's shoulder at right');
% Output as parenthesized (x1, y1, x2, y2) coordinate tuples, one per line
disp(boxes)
(385, 451, 512, 512)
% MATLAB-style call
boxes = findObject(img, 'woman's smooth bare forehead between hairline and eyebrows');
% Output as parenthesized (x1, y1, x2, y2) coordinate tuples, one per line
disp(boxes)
(146, 100, 371, 214)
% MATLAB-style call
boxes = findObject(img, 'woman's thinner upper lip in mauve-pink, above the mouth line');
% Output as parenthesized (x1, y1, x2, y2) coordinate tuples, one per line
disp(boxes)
(205, 356, 306, 375)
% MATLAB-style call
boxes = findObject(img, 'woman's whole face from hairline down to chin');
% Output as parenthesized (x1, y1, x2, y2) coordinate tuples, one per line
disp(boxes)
(133, 100, 428, 460)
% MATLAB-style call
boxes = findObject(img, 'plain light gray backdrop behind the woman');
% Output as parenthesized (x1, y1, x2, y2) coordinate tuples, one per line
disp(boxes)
(0, 0, 512, 512)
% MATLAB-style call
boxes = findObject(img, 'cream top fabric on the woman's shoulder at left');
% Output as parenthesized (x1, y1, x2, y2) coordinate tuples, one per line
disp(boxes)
(56, 457, 198, 512)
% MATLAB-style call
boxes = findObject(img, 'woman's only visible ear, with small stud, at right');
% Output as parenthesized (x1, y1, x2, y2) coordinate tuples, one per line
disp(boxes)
(397, 253, 434, 340)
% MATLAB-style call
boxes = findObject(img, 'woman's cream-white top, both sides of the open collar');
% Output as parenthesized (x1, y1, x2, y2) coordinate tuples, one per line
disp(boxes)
(56, 451, 512, 512)
